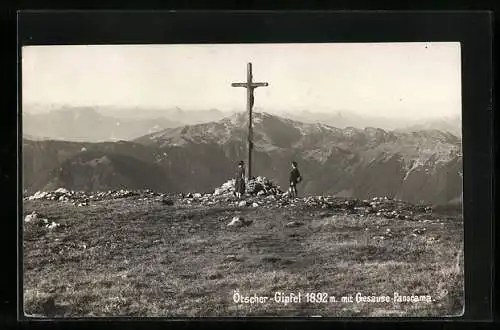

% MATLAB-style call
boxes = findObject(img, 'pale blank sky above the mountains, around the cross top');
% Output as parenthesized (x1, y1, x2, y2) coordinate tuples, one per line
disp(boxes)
(22, 43, 461, 118)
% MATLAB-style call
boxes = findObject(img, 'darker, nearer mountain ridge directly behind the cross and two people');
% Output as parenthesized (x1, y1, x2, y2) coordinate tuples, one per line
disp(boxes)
(23, 113, 462, 204)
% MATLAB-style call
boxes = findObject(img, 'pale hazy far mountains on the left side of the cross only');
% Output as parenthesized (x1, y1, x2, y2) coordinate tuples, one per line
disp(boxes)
(22, 106, 232, 142)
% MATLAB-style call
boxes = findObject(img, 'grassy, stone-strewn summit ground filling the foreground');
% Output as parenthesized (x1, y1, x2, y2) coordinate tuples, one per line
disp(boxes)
(23, 186, 463, 317)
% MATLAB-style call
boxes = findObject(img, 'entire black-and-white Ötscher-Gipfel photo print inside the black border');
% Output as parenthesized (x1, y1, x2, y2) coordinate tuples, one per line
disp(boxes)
(19, 42, 465, 318)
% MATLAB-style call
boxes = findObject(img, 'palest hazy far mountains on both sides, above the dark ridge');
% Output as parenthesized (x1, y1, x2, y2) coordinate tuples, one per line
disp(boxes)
(22, 105, 462, 142)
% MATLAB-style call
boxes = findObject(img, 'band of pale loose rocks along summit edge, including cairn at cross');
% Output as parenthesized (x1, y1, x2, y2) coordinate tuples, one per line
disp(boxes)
(25, 186, 434, 222)
